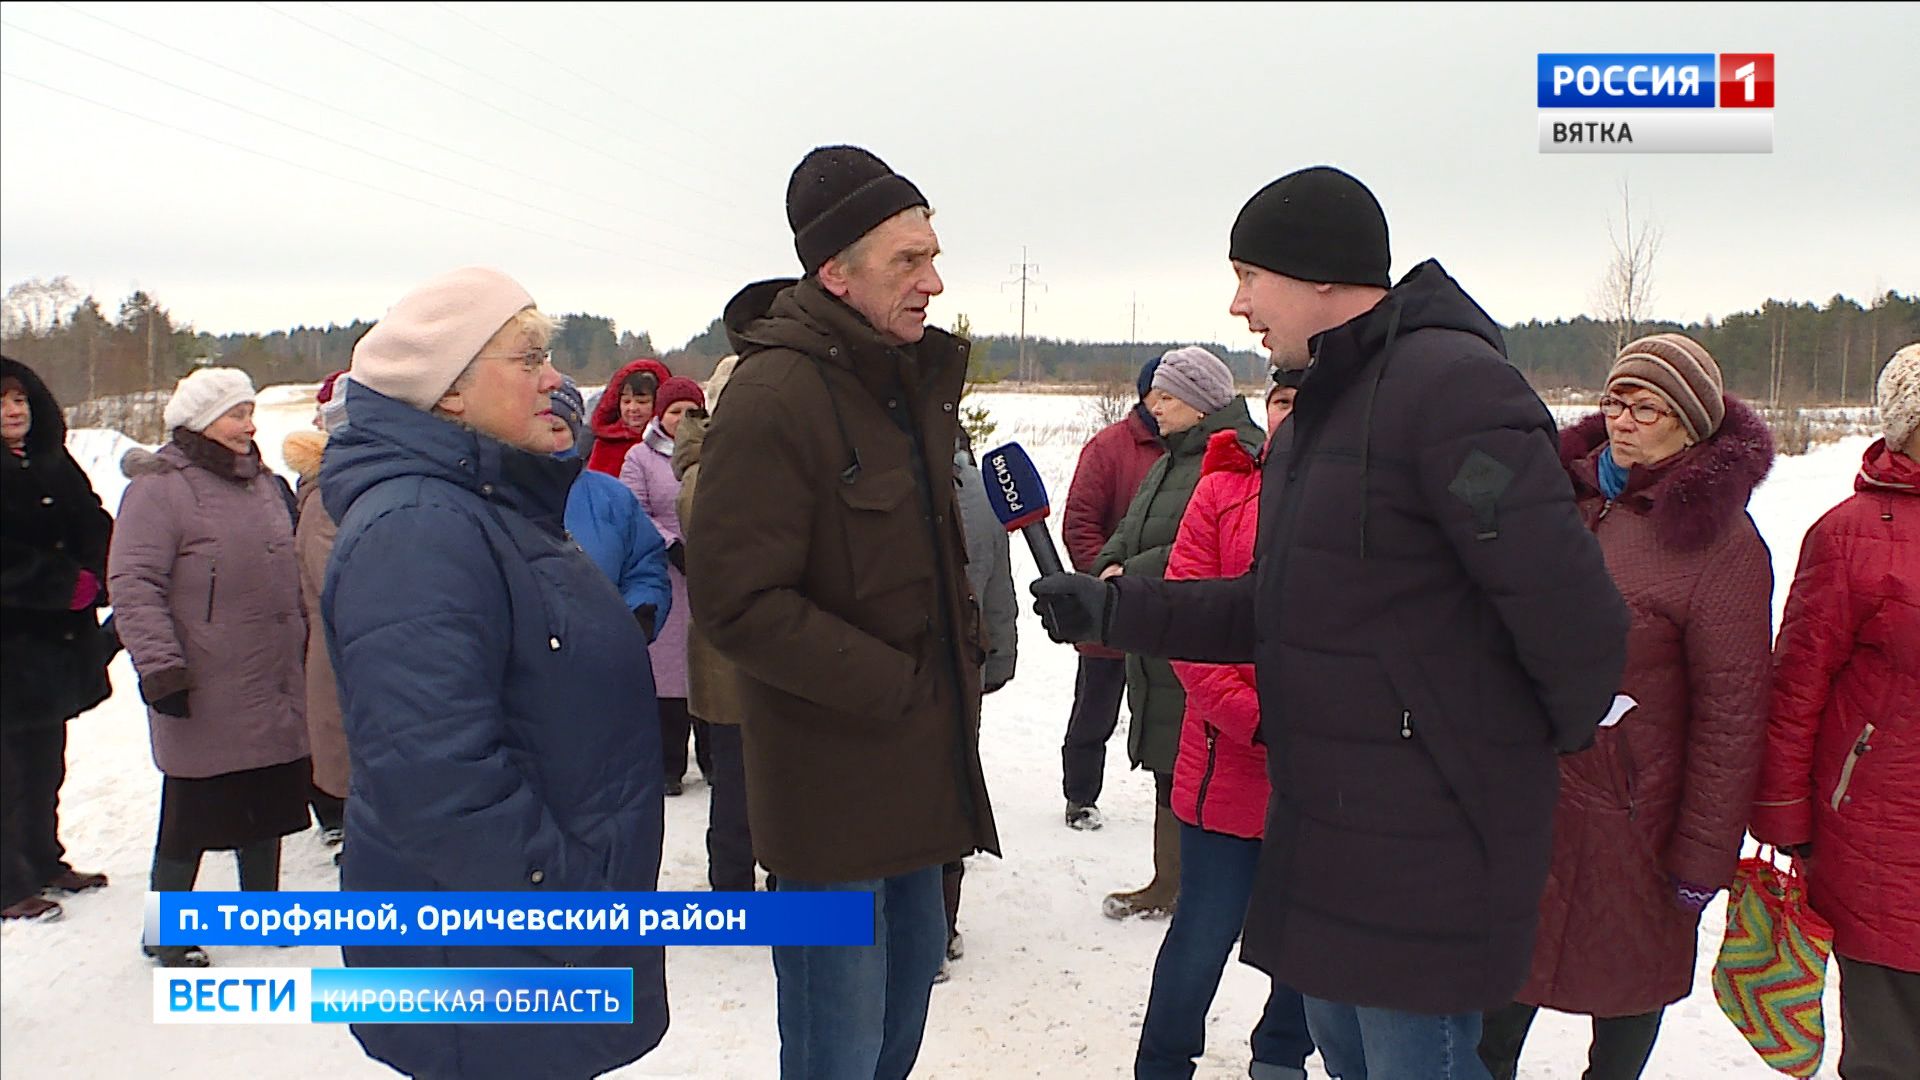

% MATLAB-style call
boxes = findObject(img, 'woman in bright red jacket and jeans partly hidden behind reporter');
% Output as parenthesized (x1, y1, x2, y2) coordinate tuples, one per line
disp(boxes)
(1133, 371, 1313, 1080)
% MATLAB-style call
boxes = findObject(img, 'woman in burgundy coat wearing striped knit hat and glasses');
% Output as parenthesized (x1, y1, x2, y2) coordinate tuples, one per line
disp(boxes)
(1480, 334, 1774, 1080)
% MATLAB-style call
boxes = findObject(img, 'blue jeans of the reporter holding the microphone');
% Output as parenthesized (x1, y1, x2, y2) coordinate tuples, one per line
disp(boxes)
(1308, 997, 1488, 1080)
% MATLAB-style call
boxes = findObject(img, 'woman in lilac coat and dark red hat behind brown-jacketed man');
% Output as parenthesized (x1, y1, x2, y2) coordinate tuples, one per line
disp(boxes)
(620, 375, 712, 796)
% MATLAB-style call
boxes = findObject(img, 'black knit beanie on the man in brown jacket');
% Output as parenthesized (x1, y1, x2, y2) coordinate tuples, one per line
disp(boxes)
(787, 146, 927, 273)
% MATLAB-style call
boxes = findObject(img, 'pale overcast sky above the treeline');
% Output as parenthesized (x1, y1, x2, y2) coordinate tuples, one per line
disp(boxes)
(0, 0, 1920, 348)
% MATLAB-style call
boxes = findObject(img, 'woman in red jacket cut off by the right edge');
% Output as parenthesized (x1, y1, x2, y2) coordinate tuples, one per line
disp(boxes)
(1747, 342, 1920, 1080)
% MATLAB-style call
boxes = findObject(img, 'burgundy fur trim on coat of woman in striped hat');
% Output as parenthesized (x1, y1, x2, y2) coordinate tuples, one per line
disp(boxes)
(1561, 394, 1774, 552)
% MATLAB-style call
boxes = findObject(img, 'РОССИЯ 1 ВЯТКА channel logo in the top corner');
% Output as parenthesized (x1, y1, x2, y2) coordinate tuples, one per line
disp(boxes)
(1534, 52, 1774, 154)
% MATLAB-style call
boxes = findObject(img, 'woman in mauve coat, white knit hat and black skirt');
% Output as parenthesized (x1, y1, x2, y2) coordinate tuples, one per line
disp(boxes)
(108, 367, 311, 967)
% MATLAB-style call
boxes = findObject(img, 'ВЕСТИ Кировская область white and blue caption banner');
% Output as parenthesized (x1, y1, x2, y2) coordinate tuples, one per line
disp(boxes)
(154, 967, 634, 1024)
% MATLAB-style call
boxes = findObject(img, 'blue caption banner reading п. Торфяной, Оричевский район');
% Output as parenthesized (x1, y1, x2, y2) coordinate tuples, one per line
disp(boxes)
(144, 890, 874, 947)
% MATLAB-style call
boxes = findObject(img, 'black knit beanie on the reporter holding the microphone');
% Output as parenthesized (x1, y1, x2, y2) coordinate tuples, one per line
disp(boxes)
(1227, 165, 1392, 288)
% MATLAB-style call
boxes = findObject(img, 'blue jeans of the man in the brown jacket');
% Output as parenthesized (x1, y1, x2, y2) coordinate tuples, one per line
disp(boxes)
(774, 867, 947, 1080)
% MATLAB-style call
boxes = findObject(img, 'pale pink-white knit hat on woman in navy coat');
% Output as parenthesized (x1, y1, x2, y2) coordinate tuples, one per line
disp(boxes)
(351, 267, 534, 409)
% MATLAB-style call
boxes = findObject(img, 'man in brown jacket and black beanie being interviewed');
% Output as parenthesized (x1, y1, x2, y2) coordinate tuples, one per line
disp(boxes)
(687, 146, 998, 1080)
